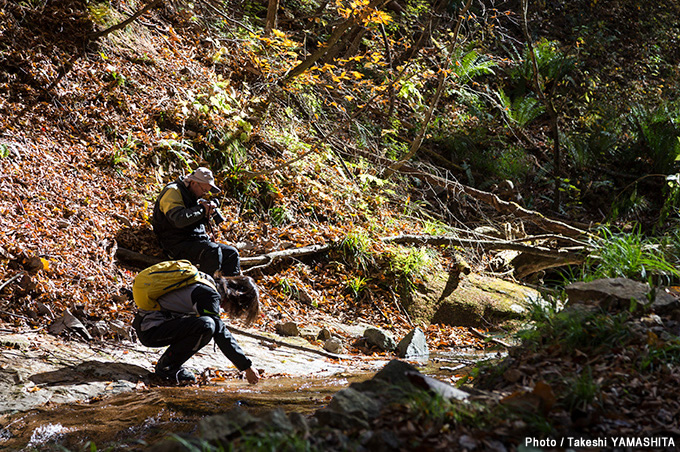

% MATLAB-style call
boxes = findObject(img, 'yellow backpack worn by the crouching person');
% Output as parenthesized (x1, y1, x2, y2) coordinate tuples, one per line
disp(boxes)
(132, 260, 217, 311)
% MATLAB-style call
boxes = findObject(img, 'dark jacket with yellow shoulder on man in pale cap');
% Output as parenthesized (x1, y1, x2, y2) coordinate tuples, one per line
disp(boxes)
(152, 178, 210, 250)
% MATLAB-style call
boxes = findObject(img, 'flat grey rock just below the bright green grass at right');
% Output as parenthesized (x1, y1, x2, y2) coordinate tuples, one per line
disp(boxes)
(565, 278, 650, 310)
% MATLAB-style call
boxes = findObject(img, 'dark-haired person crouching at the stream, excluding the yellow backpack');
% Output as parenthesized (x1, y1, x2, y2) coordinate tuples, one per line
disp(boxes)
(132, 273, 260, 384)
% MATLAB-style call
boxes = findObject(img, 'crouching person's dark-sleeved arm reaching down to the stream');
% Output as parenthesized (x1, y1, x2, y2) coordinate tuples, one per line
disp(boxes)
(191, 284, 260, 384)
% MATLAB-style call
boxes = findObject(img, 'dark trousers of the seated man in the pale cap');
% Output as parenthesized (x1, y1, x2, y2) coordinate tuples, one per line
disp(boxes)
(166, 241, 241, 276)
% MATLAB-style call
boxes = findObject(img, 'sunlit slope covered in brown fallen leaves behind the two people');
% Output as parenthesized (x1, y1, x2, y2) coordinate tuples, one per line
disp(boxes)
(0, 0, 472, 342)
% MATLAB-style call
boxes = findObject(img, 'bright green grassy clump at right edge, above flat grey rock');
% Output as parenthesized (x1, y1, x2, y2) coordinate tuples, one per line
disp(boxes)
(582, 226, 680, 282)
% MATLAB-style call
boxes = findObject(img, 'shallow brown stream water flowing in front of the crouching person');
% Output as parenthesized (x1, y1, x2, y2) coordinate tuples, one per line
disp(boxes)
(0, 352, 500, 451)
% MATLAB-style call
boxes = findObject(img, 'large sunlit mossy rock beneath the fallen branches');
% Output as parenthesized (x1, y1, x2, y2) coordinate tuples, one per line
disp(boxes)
(402, 272, 542, 328)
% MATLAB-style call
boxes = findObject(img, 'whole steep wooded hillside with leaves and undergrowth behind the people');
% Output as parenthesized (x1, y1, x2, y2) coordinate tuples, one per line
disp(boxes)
(0, 0, 678, 344)
